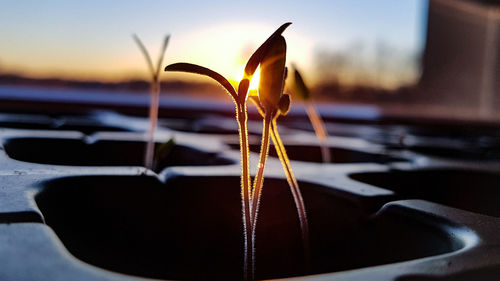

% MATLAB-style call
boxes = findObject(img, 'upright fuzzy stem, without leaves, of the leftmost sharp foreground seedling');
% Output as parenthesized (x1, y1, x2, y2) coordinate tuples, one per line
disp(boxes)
(236, 104, 254, 280)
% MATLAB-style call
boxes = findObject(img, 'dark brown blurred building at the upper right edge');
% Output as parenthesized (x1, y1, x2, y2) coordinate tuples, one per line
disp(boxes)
(419, 0, 500, 116)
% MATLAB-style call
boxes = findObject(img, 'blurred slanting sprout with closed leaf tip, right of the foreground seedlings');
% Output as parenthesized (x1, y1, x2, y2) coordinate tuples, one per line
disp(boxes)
(291, 65, 331, 163)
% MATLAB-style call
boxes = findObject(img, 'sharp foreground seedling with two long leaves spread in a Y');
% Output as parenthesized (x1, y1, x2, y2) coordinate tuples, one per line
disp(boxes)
(165, 23, 291, 280)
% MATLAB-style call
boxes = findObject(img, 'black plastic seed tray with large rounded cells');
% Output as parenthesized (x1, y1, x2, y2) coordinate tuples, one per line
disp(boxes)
(0, 105, 500, 281)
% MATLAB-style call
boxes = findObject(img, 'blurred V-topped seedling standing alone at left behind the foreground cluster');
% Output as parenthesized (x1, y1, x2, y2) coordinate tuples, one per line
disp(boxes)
(133, 34, 170, 170)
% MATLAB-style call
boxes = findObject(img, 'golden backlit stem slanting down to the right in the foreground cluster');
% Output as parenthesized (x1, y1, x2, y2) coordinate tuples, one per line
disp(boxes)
(271, 119, 311, 272)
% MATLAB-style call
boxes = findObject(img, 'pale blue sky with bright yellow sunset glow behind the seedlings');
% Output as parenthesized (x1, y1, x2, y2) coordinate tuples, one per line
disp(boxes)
(0, 0, 427, 87)
